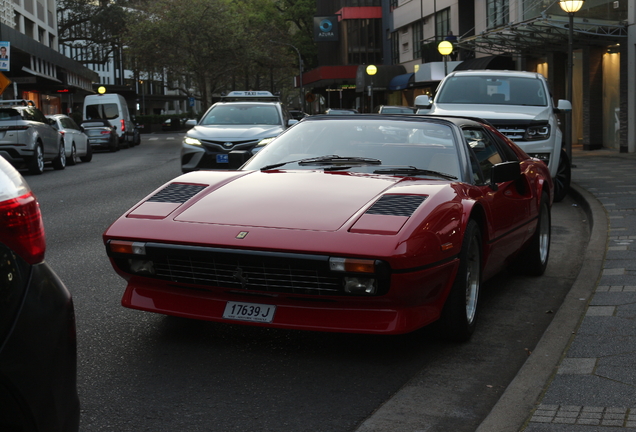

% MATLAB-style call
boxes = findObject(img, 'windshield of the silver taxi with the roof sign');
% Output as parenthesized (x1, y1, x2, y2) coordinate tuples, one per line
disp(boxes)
(199, 104, 281, 125)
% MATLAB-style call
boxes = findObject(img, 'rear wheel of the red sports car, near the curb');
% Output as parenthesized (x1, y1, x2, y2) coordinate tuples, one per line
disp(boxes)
(516, 192, 552, 276)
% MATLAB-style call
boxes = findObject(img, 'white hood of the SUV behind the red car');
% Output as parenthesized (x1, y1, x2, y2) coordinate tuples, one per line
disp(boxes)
(428, 104, 552, 122)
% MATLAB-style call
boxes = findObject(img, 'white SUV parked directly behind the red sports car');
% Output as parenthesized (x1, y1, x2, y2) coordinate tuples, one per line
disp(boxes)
(415, 70, 572, 201)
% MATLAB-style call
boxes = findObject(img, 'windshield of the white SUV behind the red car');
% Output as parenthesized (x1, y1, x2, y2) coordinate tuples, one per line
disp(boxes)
(436, 75, 548, 106)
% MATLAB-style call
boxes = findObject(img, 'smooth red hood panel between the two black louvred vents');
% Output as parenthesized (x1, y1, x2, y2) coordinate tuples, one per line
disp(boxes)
(168, 170, 428, 231)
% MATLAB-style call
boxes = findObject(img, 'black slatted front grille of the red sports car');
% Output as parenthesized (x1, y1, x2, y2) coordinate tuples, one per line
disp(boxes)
(146, 244, 342, 295)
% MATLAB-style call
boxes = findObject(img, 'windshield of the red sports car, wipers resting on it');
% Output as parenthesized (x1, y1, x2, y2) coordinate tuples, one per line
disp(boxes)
(244, 116, 460, 177)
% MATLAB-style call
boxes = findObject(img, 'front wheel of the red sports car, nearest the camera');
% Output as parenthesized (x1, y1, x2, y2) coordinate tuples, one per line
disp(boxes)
(439, 220, 482, 342)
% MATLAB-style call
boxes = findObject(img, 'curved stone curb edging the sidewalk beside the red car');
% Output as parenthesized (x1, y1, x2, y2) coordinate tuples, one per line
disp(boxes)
(476, 183, 609, 432)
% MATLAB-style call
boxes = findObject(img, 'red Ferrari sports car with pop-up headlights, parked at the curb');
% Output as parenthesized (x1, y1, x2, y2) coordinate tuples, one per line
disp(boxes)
(104, 114, 553, 340)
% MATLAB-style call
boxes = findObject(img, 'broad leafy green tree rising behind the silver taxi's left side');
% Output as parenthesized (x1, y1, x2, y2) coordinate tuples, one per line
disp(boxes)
(126, 0, 242, 106)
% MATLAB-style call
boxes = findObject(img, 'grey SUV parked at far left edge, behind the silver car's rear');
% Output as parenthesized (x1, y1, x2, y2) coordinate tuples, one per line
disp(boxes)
(0, 99, 66, 174)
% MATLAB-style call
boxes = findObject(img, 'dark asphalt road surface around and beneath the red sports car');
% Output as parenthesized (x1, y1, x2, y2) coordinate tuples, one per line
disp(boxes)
(25, 134, 589, 432)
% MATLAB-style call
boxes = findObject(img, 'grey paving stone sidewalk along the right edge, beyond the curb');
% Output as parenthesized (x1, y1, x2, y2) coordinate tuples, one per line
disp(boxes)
(522, 148, 636, 432)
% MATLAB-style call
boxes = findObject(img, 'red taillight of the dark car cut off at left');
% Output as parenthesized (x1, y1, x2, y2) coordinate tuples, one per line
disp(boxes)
(0, 192, 46, 264)
